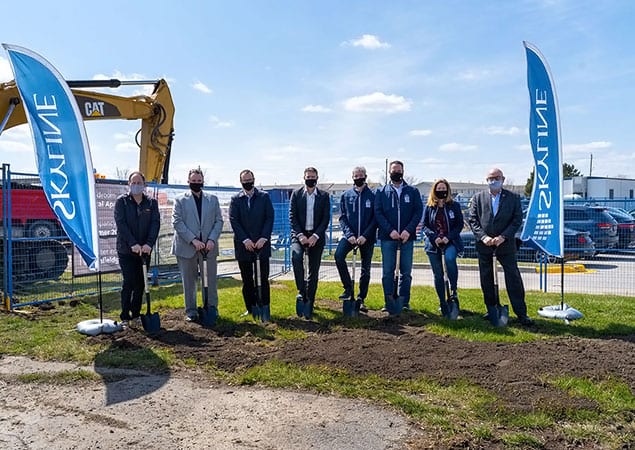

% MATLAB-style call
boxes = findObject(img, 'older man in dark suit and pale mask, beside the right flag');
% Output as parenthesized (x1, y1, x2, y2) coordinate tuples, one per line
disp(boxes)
(468, 167, 533, 325)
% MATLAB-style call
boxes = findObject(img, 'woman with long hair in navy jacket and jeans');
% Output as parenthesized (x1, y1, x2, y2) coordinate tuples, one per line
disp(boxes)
(422, 179, 463, 317)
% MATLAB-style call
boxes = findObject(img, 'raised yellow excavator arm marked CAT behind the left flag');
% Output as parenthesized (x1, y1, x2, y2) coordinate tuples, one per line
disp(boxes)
(0, 79, 174, 183)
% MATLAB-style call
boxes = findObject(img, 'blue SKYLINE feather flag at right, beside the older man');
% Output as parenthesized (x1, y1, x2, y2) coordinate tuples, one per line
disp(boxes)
(521, 42, 564, 258)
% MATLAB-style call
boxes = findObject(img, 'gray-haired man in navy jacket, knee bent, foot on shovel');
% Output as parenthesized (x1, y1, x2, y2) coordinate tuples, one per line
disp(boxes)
(335, 167, 377, 312)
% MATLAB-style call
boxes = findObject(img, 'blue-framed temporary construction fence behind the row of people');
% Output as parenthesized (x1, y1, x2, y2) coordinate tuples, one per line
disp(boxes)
(1, 165, 635, 308)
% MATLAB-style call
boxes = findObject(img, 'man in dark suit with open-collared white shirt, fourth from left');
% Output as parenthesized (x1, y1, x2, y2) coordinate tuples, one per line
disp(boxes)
(289, 167, 331, 319)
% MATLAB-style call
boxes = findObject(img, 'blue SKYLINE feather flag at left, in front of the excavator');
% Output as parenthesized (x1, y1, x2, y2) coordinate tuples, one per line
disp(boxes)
(2, 44, 99, 271)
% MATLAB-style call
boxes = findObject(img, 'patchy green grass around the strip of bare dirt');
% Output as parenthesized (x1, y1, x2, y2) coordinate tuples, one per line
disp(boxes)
(0, 278, 635, 448)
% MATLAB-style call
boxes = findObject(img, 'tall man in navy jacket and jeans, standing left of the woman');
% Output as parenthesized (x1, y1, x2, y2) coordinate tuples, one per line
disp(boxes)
(375, 161, 423, 310)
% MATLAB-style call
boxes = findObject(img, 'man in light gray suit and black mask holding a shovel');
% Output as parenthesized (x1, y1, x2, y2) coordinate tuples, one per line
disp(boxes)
(172, 168, 223, 322)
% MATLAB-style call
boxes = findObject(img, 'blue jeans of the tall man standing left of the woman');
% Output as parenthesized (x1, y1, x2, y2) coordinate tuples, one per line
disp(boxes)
(381, 240, 414, 306)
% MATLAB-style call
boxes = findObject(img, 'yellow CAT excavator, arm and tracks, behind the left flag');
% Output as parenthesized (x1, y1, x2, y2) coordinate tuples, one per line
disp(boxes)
(0, 79, 174, 286)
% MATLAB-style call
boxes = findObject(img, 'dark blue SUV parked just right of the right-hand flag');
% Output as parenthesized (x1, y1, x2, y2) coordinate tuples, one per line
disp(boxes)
(563, 205, 619, 252)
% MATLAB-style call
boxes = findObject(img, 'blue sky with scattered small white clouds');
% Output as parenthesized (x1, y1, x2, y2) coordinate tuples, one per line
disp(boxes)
(0, 0, 635, 186)
